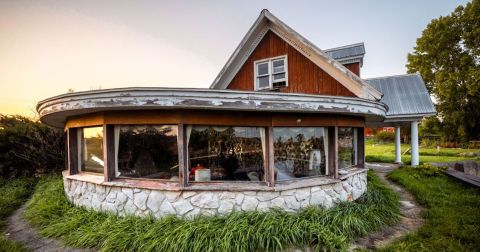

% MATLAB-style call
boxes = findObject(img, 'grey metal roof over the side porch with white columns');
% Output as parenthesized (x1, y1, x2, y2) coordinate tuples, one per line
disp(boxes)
(365, 74, 436, 119)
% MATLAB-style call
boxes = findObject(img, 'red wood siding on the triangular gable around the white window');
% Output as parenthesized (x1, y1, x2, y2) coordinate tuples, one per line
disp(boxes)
(227, 31, 355, 97)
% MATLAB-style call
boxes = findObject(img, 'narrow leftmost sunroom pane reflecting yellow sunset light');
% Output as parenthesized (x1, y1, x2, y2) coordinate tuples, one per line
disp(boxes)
(81, 127, 104, 174)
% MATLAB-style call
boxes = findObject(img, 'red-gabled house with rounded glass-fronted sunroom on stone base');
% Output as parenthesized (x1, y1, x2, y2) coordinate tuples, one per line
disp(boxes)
(37, 10, 435, 217)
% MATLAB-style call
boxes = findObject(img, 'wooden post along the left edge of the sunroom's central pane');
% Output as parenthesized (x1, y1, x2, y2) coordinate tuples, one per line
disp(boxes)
(177, 124, 190, 188)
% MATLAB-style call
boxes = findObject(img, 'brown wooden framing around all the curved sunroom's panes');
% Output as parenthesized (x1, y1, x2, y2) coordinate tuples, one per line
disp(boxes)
(66, 111, 365, 186)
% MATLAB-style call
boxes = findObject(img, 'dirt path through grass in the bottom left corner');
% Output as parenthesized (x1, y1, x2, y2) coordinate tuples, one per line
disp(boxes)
(5, 205, 92, 252)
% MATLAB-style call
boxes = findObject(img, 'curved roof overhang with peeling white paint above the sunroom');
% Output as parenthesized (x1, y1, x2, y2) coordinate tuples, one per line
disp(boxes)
(37, 88, 387, 128)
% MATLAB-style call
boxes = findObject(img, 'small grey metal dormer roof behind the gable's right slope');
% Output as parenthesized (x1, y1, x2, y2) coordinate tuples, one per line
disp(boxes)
(324, 42, 365, 66)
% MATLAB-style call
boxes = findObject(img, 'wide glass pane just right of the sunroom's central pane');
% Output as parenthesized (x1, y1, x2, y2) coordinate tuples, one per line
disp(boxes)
(273, 127, 328, 181)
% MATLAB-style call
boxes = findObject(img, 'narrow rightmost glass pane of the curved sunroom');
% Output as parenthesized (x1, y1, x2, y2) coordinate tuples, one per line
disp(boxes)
(338, 128, 355, 169)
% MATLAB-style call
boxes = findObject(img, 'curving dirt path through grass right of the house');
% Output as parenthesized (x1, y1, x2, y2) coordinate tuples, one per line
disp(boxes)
(352, 163, 424, 250)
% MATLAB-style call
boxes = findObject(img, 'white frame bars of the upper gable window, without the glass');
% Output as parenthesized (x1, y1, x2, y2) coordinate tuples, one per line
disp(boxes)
(253, 55, 288, 91)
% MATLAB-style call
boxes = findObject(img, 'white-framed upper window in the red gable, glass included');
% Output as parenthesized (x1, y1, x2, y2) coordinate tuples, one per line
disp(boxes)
(254, 55, 288, 90)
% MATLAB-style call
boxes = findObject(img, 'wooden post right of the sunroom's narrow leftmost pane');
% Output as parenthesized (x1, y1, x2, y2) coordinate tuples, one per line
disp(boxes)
(103, 124, 116, 181)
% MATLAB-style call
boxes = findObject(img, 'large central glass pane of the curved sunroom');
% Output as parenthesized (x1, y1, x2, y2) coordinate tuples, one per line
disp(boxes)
(187, 126, 265, 182)
